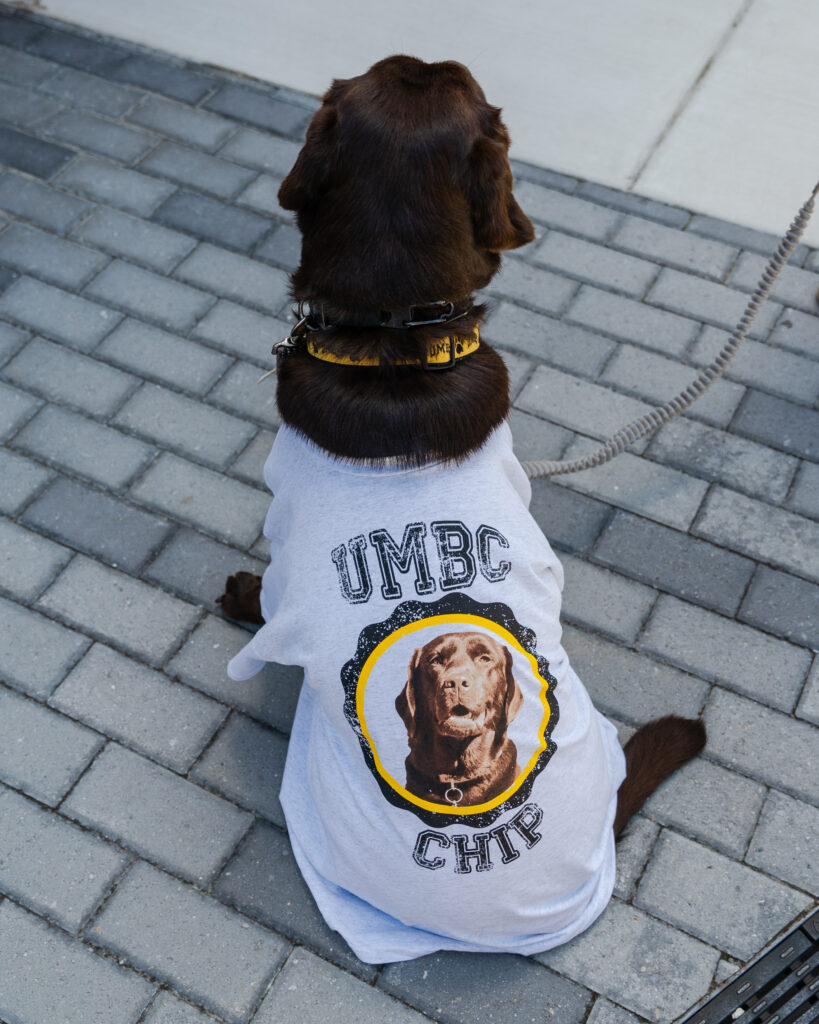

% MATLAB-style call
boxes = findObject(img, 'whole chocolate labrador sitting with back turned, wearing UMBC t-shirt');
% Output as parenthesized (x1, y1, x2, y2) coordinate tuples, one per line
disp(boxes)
(220, 56, 704, 963)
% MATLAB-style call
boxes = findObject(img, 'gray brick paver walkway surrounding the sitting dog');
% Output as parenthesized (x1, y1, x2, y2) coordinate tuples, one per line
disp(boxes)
(0, 8, 819, 1024)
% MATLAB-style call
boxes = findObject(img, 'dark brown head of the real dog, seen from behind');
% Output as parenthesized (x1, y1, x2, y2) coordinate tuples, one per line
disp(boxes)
(278, 56, 534, 309)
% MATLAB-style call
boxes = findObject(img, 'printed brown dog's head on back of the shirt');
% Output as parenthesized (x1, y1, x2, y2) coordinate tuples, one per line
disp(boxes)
(395, 633, 523, 748)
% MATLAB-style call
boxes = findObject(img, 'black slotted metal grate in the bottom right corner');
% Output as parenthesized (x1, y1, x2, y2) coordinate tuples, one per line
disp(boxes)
(679, 910, 819, 1024)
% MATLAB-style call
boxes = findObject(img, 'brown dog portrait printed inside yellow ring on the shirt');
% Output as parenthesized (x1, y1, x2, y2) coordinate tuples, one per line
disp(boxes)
(395, 632, 523, 807)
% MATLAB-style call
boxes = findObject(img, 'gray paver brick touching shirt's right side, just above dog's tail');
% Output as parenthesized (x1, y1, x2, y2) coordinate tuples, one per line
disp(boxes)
(563, 627, 708, 725)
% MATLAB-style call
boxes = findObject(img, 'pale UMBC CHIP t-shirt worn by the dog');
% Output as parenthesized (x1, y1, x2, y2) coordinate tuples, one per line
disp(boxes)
(228, 424, 624, 964)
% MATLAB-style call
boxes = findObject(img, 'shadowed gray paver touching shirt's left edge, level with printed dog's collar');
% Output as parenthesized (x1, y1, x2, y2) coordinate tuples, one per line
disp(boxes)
(190, 713, 288, 827)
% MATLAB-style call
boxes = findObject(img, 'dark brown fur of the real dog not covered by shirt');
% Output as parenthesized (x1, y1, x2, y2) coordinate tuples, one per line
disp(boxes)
(220, 56, 704, 834)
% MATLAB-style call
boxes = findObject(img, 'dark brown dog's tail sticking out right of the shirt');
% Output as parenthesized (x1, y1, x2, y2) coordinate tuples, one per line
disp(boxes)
(614, 715, 705, 836)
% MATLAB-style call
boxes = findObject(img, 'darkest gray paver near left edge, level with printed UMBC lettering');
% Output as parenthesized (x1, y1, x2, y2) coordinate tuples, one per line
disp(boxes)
(23, 477, 172, 572)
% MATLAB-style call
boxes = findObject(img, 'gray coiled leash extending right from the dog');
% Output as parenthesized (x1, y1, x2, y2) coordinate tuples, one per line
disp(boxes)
(522, 182, 819, 479)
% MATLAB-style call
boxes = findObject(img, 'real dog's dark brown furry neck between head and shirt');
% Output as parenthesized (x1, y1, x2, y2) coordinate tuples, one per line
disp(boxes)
(277, 310, 509, 467)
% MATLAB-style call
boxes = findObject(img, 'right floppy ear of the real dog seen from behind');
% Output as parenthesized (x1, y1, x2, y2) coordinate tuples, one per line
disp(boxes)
(467, 113, 534, 253)
